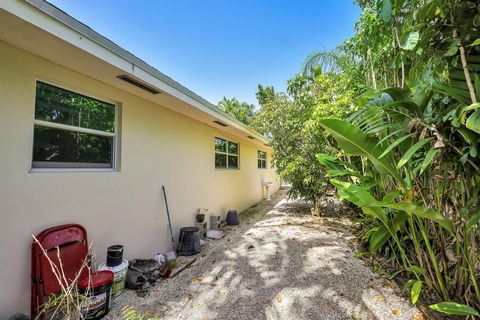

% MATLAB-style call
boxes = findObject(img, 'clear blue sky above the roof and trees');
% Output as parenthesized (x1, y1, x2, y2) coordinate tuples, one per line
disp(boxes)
(49, 0, 360, 105)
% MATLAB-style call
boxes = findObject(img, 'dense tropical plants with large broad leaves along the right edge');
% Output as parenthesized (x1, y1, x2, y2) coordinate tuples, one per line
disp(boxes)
(312, 0, 480, 316)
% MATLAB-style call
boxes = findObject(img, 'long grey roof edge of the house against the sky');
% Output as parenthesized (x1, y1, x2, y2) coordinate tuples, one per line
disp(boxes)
(25, 0, 268, 142)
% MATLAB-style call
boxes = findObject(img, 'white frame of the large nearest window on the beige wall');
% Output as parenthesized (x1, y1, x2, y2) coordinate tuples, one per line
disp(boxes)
(30, 78, 120, 173)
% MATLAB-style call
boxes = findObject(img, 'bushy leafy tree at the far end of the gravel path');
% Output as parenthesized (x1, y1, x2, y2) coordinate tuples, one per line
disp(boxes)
(251, 68, 353, 203)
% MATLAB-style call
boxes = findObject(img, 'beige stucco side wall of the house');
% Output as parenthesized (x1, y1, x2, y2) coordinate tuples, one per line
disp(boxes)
(0, 42, 279, 319)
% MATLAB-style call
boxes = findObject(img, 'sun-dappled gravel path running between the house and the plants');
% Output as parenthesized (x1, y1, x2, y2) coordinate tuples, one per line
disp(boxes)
(108, 190, 423, 320)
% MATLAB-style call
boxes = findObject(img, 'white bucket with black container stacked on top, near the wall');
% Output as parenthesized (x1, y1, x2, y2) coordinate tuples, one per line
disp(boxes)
(98, 245, 128, 298)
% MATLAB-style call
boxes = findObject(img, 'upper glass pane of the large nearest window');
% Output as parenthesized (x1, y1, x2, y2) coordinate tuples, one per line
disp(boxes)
(35, 82, 115, 132)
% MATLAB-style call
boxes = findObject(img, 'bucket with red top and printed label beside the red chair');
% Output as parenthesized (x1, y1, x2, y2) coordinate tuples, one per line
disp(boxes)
(78, 270, 113, 320)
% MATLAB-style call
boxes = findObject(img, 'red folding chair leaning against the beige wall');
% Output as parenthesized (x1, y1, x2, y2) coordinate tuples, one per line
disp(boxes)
(31, 224, 88, 319)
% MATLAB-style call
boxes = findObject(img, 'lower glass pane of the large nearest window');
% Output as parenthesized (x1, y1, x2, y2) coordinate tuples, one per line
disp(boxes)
(33, 126, 113, 168)
